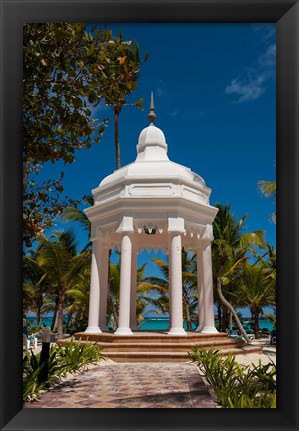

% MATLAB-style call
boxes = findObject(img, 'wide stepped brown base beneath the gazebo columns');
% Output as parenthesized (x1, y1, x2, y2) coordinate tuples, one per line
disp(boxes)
(70, 331, 262, 362)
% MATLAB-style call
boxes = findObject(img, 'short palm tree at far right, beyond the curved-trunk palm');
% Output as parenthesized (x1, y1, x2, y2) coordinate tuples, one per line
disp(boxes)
(237, 263, 275, 338)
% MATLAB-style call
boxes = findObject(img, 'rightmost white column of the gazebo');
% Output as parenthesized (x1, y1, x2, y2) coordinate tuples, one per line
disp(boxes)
(201, 241, 218, 334)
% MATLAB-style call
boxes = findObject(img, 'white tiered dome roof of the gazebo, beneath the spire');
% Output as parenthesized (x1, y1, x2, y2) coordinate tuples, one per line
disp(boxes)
(97, 124, 211, 205)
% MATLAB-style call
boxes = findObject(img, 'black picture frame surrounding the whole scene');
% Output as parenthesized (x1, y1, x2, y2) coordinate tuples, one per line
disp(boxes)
(0, 0, 299, 431)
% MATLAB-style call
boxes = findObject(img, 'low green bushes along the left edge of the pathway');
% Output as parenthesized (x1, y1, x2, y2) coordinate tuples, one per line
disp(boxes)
(23, 339, 107, 402)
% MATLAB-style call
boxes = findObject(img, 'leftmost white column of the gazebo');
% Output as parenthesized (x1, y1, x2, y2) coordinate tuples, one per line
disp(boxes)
(85, 238, 102, 333)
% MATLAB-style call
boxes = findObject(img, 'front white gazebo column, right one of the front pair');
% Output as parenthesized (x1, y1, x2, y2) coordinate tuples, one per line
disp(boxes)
(168, 233, 187, 335)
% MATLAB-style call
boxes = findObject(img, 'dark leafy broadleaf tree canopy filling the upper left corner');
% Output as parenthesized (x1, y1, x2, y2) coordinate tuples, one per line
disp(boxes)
(23, 23, 146, 246)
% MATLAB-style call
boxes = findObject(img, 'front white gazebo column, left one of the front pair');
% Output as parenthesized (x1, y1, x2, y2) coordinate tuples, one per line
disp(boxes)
(115, 233, 133, 335)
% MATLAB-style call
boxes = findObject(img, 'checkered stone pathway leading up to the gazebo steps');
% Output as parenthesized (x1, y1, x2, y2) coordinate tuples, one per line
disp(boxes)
(24, 362, 216, 408)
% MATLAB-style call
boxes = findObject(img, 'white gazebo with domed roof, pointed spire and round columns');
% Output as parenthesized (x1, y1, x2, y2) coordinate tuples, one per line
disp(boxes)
(86, 96, 217, 335)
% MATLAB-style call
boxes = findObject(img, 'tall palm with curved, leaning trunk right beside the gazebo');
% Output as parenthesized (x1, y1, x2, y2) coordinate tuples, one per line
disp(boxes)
(212, 204, 265, 343)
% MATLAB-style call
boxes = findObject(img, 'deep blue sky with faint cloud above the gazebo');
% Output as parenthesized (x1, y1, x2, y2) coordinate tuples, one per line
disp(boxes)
(37, 23, 276, 280)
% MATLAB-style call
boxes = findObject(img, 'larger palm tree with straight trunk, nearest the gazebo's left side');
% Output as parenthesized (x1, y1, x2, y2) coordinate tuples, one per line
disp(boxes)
(38, 230, 90, 338)
